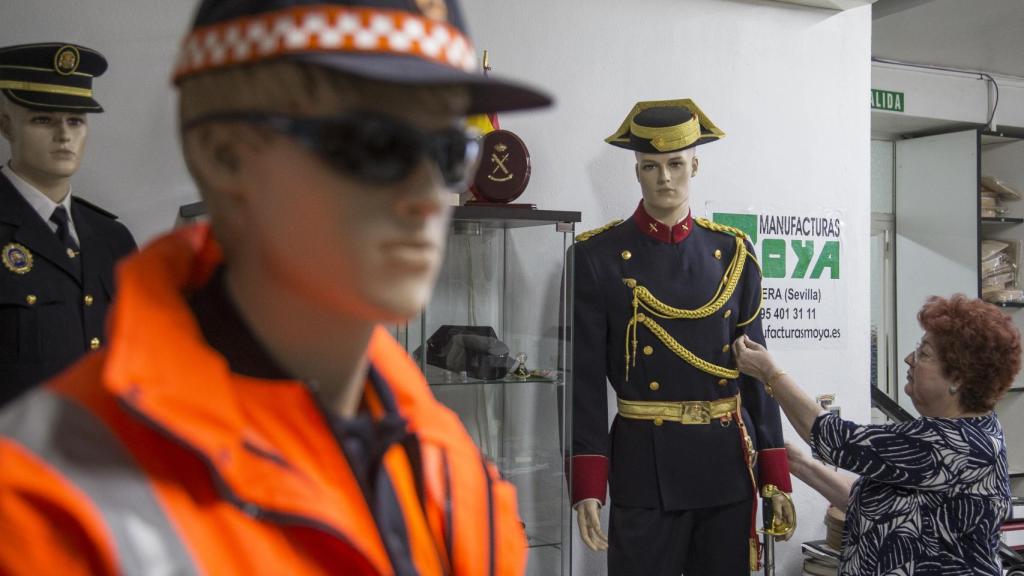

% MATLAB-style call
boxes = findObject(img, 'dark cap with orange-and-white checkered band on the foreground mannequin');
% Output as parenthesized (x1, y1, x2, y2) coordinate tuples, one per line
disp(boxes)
(180, 0, 551, 114)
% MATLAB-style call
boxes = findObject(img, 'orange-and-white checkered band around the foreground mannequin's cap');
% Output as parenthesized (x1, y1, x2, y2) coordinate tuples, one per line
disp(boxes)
(174, 5, 477, 81)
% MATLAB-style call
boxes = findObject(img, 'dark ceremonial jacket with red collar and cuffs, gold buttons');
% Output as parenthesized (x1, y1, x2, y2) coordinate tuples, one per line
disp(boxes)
(572, 207, 788, 510)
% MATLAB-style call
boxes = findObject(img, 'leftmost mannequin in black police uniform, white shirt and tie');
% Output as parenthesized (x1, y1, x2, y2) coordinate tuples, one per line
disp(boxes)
(0, 43, 135, 404)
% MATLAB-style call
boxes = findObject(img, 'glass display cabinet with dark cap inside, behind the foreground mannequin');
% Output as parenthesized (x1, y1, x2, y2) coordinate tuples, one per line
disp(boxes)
(394, 205, 580, 576)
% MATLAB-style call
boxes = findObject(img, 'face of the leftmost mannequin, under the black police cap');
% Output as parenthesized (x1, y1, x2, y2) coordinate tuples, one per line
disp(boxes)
(0, 100, 89, 187)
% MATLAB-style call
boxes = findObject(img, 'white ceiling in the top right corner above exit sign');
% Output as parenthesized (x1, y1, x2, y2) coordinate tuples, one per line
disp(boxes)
(871, 0, 1024, 78)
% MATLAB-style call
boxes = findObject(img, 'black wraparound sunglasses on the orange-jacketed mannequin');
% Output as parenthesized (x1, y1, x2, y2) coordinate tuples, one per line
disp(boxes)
(182, 112, 480, 187)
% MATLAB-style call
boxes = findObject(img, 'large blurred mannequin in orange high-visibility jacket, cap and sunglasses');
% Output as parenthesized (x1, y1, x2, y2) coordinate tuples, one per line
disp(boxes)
(0, 0, 549, 575)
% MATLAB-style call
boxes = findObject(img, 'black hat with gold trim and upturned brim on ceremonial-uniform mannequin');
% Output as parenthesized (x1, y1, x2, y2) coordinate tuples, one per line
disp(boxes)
(604, 99, 725, 154)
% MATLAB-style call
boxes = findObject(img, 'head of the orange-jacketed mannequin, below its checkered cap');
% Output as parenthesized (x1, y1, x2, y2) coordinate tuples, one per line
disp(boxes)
(180, 60, 469, 322)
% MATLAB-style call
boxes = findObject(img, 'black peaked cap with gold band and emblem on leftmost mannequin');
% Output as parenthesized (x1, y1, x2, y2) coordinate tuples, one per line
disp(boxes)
(0, 42, 106, 113)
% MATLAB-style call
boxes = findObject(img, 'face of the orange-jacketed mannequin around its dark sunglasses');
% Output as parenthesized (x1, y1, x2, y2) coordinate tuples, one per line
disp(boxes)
(212, 82, 463, 322)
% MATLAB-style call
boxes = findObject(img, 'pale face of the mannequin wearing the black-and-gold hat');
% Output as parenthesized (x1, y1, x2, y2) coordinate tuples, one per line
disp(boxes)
(636, 148, 697, 217)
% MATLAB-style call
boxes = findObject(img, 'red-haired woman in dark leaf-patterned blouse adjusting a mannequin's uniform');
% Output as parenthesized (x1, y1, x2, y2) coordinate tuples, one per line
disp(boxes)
(733, 294, 1021, 576)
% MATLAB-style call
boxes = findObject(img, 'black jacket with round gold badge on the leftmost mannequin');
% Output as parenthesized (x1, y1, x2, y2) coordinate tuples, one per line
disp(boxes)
(0, 173, 135, 404)
